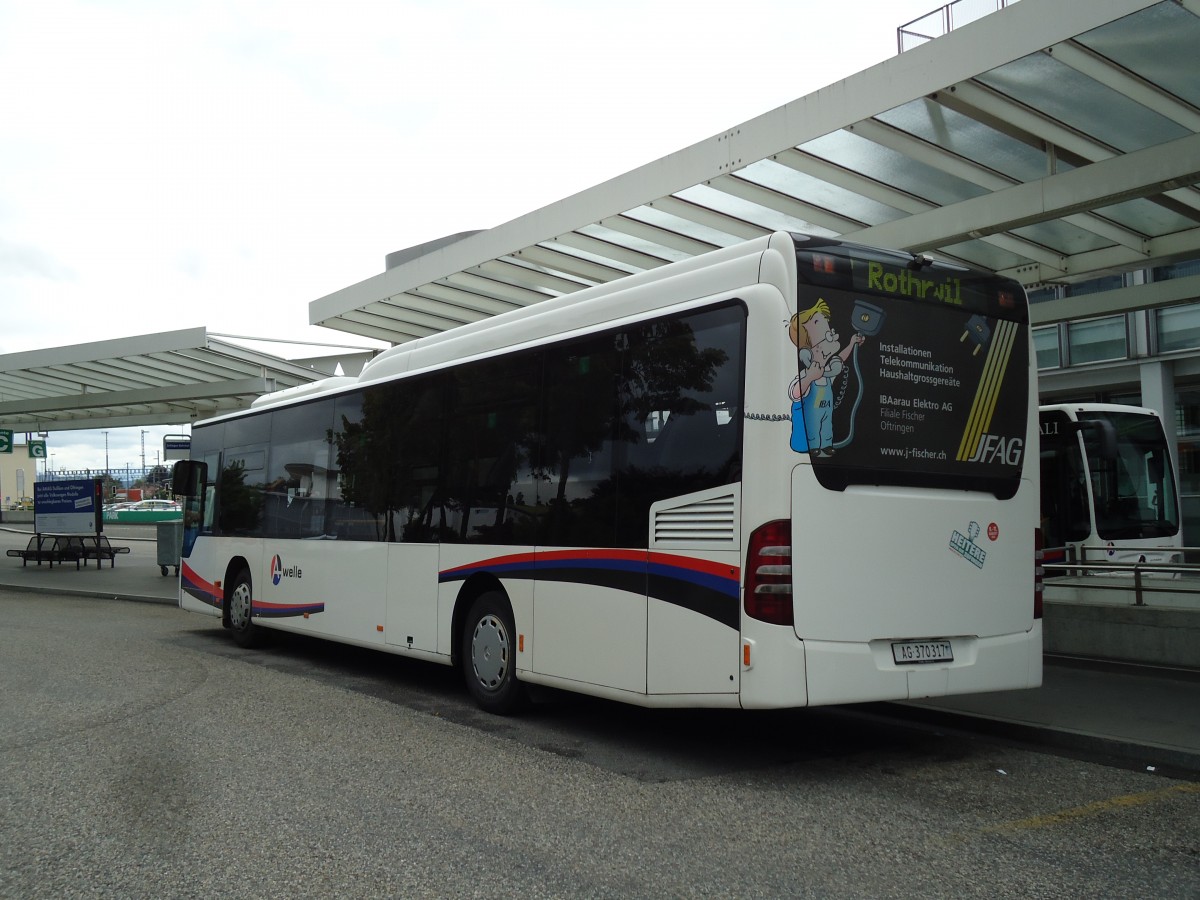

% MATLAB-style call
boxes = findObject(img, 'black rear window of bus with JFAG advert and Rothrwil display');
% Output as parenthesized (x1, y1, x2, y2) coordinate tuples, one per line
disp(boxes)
(790, 246, 1031, 498)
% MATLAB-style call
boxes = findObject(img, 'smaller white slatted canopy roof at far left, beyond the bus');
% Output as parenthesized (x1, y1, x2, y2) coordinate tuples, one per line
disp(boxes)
(0, 328, 328, 431)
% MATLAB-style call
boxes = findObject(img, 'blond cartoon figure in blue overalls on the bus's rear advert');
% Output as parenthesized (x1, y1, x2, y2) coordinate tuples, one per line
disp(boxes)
(787, 300, 866, 456)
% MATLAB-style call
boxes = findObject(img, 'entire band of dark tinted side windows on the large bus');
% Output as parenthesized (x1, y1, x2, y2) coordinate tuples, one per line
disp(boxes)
(211, 305, 745, 547)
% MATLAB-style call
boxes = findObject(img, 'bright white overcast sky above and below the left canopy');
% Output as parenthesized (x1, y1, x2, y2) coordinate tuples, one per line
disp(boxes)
(0, 0, 938, 480)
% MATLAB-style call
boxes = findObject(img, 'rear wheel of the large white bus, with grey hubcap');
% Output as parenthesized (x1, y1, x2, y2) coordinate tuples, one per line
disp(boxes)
(458, 590, 526, 715)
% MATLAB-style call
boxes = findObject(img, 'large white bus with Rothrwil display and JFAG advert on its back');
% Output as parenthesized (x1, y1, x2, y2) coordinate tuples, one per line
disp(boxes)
(174, 233, 1042, 713)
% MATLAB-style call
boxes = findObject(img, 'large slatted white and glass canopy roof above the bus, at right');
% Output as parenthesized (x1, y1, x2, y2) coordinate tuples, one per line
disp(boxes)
(310, 0, 1200, 344)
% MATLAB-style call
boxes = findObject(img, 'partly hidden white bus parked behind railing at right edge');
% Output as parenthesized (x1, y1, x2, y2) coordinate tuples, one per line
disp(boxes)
(1038, 403, 1183, 563)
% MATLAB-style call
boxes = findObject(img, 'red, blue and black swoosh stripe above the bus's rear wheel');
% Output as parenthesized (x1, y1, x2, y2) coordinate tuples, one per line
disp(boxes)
(438, 550, 740, 630)
